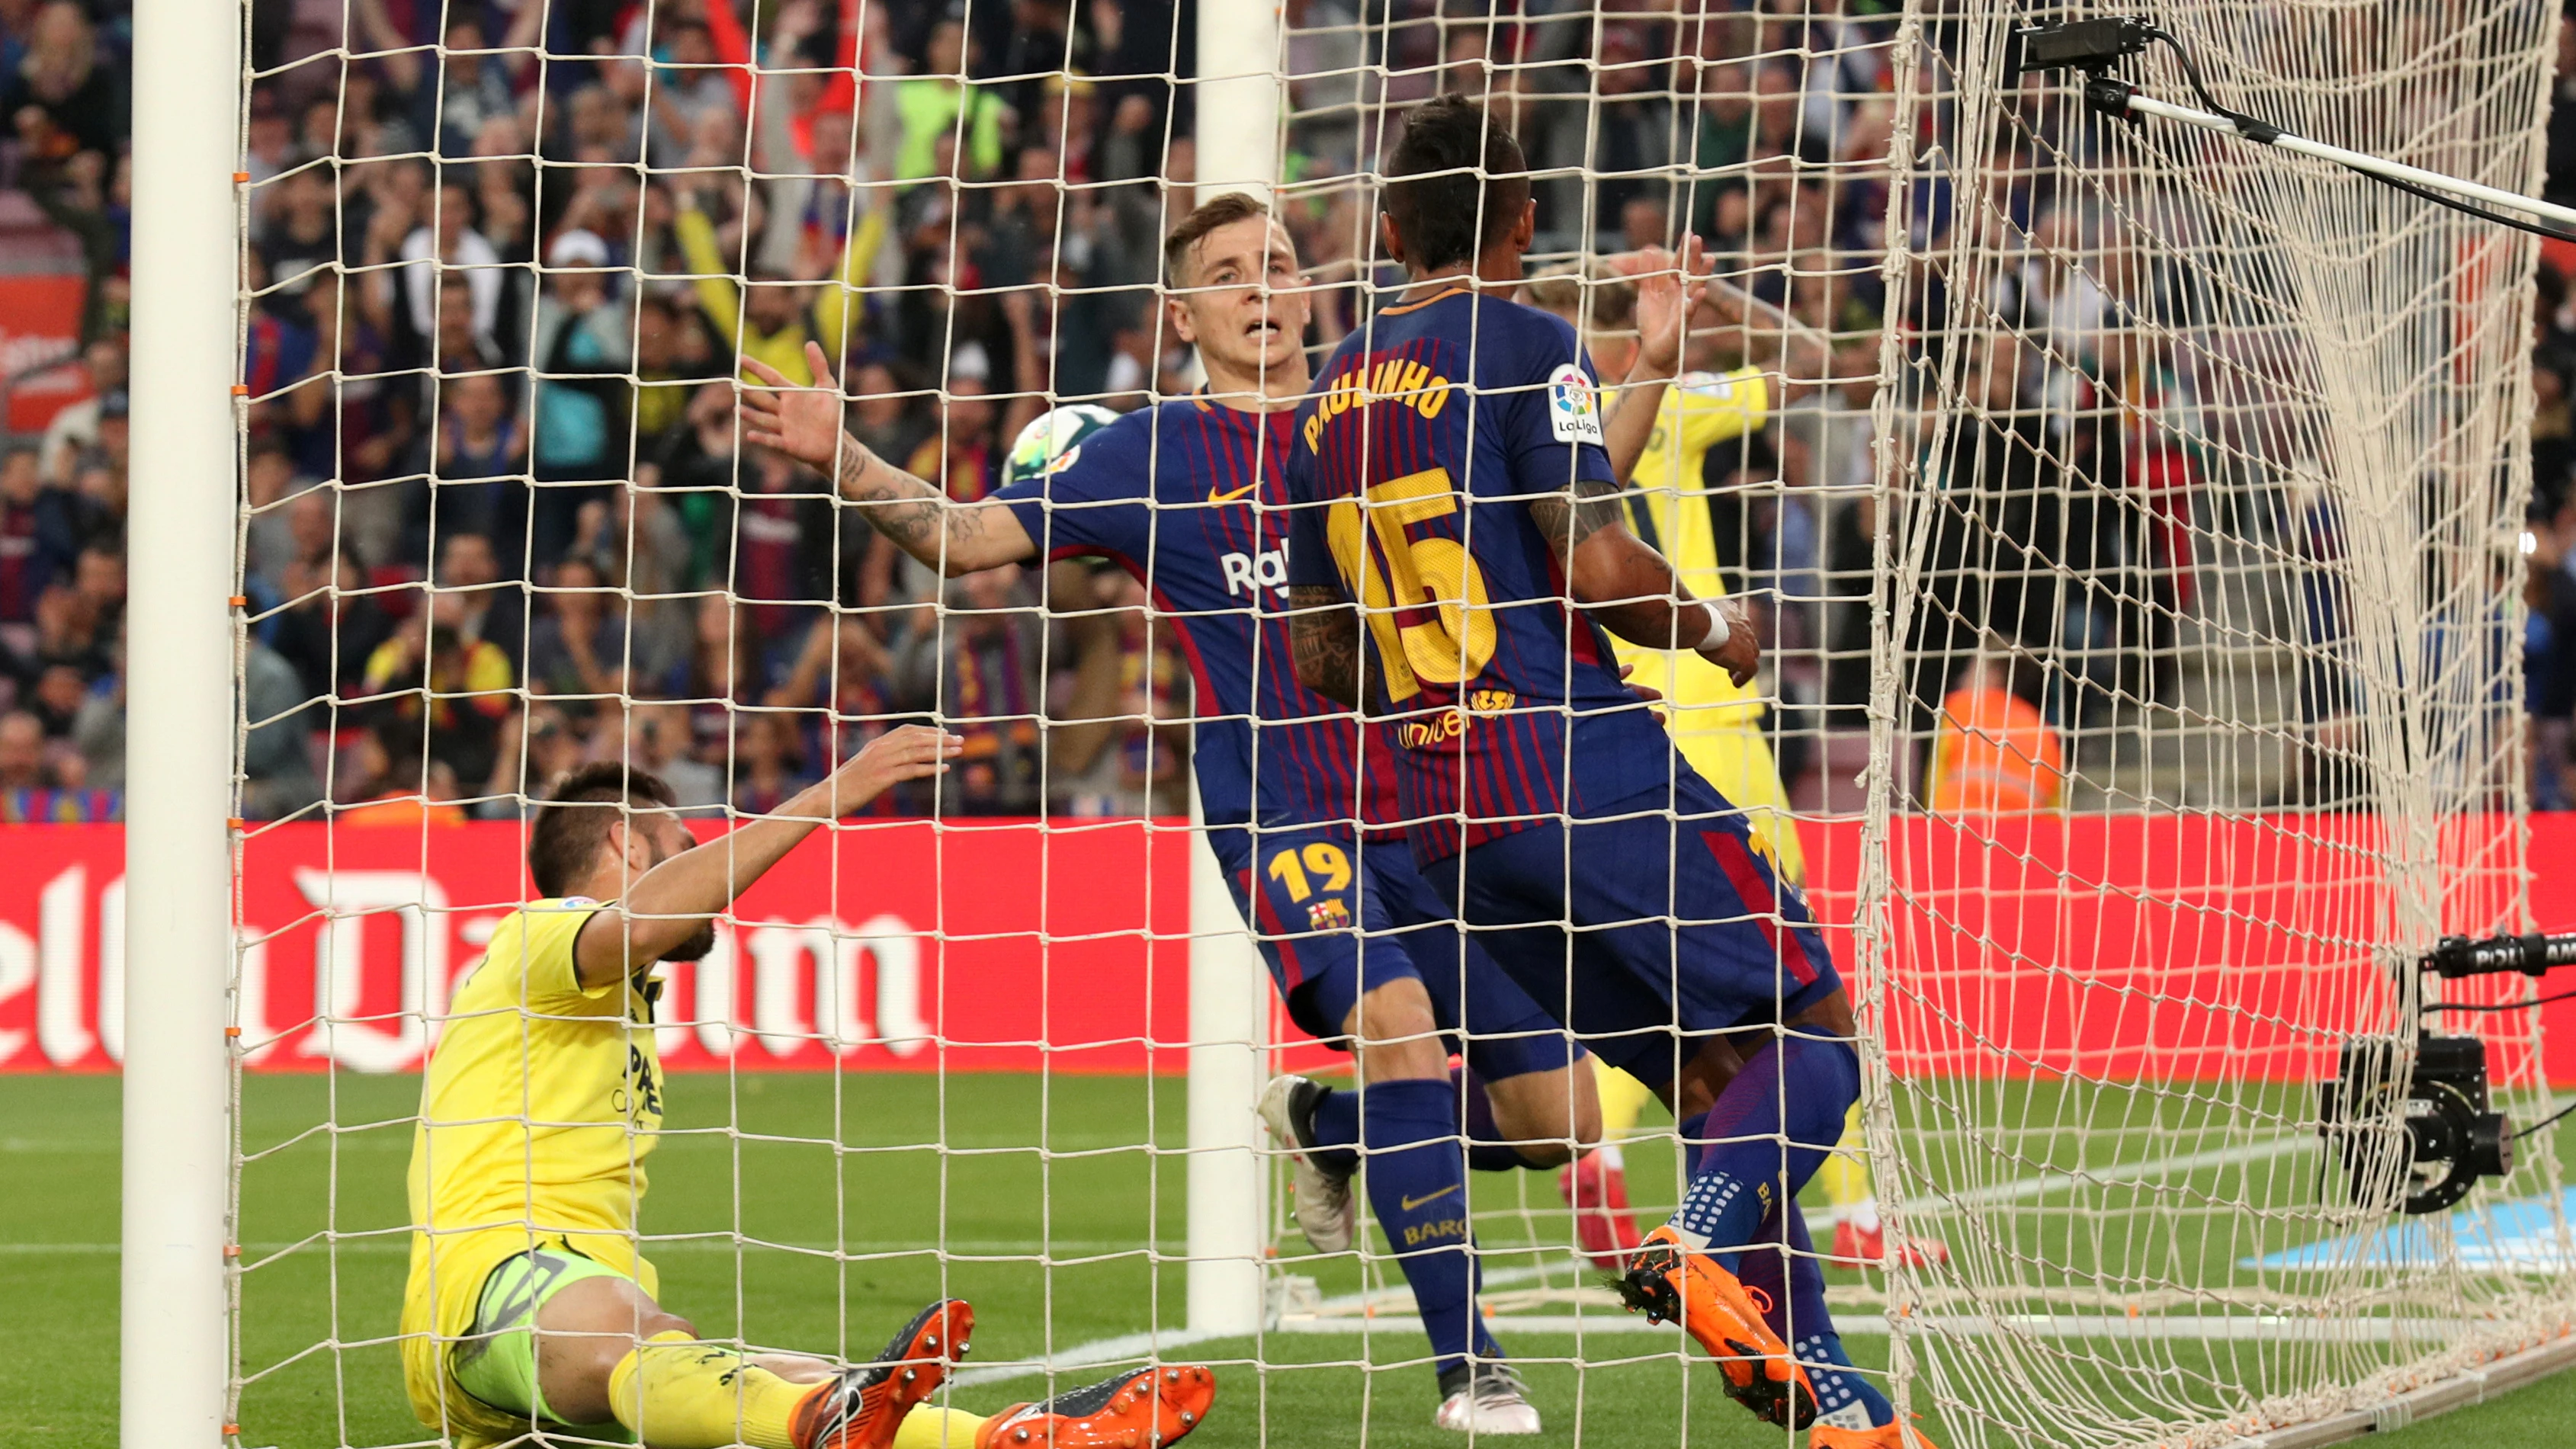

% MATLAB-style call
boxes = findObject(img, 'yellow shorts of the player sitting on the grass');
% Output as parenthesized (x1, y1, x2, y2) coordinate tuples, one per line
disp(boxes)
(402, 1228, 662, 1449)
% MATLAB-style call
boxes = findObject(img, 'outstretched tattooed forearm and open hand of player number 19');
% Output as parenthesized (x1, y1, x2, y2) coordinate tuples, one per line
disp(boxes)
(742, 342, 1038, 576)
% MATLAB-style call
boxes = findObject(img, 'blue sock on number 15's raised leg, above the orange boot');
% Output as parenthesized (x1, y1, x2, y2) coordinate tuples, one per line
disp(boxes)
(1672, 1037, 1860, 1271)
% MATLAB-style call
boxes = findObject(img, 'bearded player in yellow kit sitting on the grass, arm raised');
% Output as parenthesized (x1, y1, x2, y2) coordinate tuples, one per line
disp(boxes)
(402, 726, 1216, 1449)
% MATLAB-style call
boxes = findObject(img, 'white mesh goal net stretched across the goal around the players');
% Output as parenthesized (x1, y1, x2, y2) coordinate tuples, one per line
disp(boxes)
(211, 0, 2576, 1447)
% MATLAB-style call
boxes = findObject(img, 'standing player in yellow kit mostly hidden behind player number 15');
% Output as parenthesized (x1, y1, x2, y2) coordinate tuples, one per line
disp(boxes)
(1522, 258, 1948, 1266)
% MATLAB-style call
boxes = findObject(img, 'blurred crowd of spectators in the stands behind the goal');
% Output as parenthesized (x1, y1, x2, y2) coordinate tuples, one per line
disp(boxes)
(0, 0, 2576, 823)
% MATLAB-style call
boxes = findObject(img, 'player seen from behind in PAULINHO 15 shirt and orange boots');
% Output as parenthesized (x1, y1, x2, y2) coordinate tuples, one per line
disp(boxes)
(1288, 95, 1922, 1449)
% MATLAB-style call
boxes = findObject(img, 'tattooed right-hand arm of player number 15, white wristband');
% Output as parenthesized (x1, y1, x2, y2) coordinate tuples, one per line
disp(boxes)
(1514, 479, 1762, 684)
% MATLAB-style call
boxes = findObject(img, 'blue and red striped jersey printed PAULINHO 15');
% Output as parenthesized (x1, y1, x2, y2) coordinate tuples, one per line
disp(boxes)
(1288, 288, 1672, 862)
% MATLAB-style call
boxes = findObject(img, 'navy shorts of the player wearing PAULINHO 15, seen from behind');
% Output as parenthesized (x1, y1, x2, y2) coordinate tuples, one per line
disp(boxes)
(1427, 770, 1842, 1086)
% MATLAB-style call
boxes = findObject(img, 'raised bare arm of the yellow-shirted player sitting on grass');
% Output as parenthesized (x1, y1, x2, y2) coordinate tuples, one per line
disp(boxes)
(572, 726, 966, 986)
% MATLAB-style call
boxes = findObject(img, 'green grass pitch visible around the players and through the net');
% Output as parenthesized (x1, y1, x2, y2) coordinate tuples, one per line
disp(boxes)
(14, 1076, 2576, 1449)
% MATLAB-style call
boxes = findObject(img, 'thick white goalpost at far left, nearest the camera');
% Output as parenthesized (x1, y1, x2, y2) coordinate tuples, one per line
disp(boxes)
(126, 0, 245, 1449)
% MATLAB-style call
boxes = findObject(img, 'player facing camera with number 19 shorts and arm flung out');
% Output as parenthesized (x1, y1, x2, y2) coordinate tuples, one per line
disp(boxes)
(742, 196, 1599, 1434)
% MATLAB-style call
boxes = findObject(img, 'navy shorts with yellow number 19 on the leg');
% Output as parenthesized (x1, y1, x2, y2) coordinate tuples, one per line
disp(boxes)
(1208, 826, 1582, 1081)
